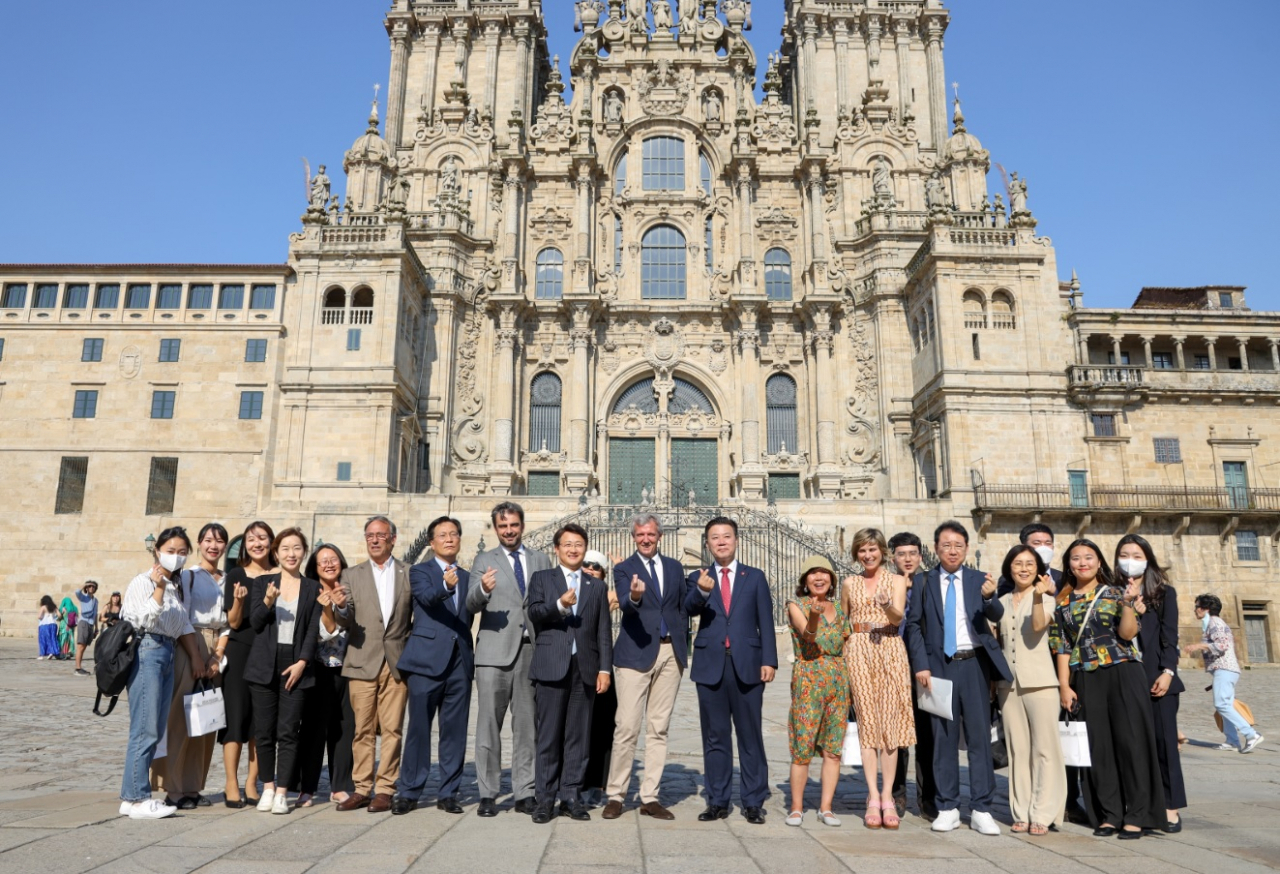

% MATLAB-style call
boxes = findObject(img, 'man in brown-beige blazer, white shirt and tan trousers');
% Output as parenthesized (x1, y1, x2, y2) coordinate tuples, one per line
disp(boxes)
(334, 516, 413, 814)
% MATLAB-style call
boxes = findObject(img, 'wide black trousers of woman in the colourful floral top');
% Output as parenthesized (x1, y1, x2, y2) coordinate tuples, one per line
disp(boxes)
(1075, 662, 1176, 828)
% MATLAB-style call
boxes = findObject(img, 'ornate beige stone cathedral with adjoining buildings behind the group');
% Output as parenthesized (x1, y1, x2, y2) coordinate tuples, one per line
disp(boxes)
(0, 0, 1280, 663)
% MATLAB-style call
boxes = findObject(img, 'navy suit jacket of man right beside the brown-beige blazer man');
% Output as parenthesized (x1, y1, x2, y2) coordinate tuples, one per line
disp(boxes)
(396, 555, 475, 681)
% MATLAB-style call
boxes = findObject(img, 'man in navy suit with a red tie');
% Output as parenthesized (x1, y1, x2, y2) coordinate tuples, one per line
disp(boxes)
(685, 516, 778, 825)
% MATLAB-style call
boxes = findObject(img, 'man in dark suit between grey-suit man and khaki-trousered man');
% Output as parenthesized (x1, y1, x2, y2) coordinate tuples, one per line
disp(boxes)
(527, 523, 613, 824)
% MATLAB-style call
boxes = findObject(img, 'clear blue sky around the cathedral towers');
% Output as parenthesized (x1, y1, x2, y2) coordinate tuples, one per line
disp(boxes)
(0, 0, 1280, 310)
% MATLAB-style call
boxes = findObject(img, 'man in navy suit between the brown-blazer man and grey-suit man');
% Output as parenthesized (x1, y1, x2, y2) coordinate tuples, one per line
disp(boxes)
(392, 516, 475, 814)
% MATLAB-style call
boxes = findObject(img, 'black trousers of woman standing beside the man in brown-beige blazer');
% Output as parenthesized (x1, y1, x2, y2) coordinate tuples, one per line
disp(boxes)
(289, 664, 356, 795)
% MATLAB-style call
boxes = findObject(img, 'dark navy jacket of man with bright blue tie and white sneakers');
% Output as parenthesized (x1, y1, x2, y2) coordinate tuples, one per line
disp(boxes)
(906, 564, 1014, 682)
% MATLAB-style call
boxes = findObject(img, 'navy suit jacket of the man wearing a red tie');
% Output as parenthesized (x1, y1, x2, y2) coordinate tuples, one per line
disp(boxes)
(685, 562, 778, 686)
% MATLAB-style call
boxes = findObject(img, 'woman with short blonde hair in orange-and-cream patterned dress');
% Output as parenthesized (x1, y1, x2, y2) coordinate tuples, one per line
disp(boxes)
(841, 528, 915, 829)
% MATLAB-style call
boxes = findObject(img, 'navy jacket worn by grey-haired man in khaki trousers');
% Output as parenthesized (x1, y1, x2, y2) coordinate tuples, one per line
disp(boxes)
(613, 553, 689, 671)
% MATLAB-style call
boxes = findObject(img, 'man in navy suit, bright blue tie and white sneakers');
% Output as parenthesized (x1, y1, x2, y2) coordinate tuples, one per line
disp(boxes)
(906, 521, 1012, 834)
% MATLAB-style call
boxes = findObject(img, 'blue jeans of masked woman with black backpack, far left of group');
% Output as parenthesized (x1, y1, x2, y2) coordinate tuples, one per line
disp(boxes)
(120, 635, 174, 802)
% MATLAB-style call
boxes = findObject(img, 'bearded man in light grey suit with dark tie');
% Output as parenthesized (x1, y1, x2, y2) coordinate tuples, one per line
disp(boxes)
(467, 502, 552, 816)
